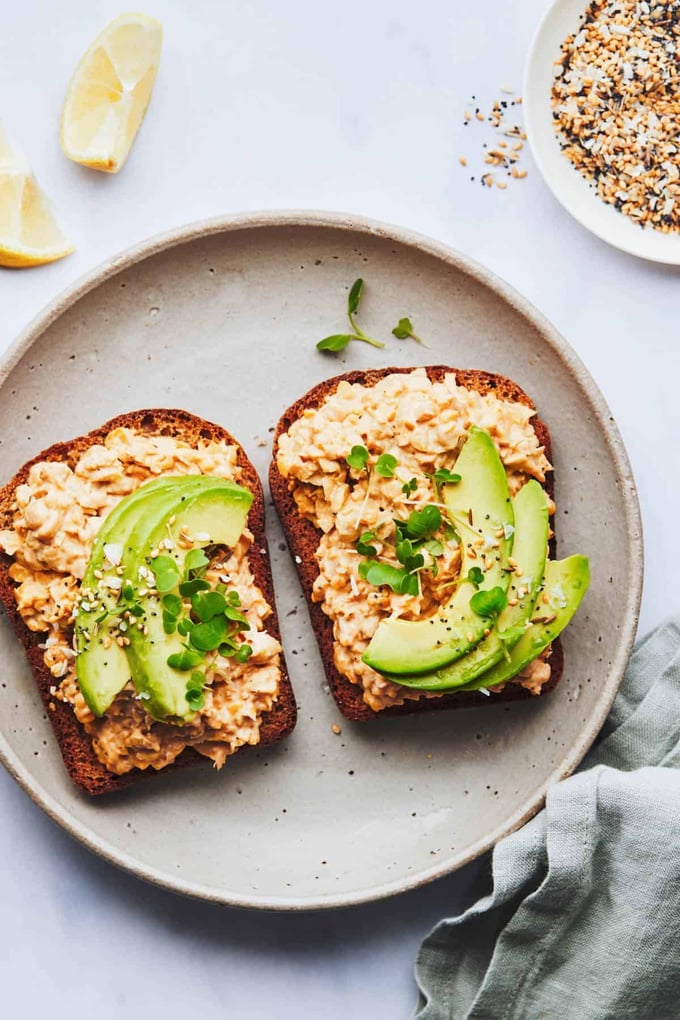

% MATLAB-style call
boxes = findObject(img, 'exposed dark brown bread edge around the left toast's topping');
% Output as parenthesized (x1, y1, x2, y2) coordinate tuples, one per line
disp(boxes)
(0, 408, 297, 795)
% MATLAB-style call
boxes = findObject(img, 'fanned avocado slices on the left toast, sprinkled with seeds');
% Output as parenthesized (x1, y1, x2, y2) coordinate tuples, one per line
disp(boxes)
(74, 475, 253, 720)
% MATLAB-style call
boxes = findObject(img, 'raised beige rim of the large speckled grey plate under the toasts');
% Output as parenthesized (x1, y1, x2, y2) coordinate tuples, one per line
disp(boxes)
(0, 210, 643, 912)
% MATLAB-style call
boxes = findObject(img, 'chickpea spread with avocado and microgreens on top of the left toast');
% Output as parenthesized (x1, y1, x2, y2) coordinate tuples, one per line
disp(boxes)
(0, 412, 289, 776)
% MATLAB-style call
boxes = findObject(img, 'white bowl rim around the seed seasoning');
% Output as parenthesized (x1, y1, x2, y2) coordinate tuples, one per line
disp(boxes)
(523, 0, 680, 265)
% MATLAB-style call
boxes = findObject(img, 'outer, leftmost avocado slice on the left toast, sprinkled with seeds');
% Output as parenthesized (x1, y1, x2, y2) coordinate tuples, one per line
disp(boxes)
(74, 475, 252, 716)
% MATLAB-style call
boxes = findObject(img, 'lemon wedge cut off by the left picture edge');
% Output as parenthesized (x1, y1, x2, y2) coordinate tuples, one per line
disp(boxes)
(0, 126, 73, 268)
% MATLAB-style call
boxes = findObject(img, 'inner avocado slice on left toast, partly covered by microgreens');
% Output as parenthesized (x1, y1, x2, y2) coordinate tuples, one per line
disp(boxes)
(123, 476, 253, 722)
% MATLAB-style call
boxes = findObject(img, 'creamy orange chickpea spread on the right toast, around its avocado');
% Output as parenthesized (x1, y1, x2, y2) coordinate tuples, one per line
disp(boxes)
(276, 368, 551, 712)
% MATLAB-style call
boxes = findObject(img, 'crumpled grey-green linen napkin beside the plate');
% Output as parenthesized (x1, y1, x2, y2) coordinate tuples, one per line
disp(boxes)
(415, 618, 680, 1020)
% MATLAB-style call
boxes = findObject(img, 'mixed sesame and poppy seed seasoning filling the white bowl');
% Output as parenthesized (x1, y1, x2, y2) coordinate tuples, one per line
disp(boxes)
(553, 0, 680, 234)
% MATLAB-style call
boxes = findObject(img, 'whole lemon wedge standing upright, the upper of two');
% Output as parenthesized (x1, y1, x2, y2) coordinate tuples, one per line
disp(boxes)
(61, 14, 163, 173)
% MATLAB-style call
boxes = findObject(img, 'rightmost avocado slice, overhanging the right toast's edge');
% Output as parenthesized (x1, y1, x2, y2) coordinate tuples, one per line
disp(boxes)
(461, 556, 590, 691)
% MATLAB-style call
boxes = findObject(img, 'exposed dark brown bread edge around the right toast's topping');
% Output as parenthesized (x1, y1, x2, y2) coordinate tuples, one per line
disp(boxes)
(269, 365, 564, 721)
